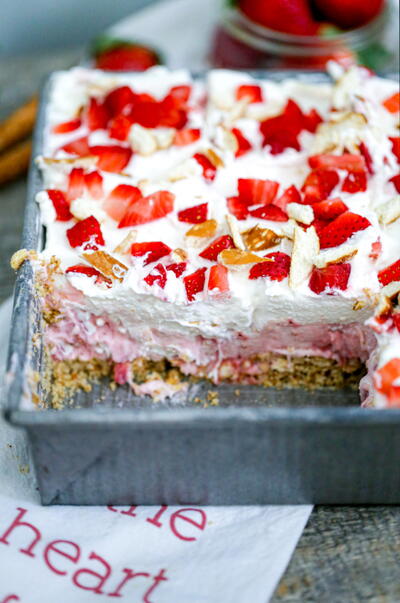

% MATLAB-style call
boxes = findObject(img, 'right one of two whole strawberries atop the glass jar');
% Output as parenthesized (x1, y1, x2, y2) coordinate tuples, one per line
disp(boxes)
(314, 0, 385, 29)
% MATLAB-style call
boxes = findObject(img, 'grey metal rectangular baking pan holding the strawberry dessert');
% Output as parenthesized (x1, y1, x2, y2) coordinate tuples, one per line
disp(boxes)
(5, 71, 400, 505)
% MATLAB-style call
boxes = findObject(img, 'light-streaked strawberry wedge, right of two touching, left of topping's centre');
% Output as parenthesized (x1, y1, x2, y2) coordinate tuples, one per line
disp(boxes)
(118, 191, 175, 228)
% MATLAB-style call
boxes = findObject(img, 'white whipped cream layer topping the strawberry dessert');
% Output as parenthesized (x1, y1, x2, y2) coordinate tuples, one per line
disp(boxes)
(37, 66, 400, 406)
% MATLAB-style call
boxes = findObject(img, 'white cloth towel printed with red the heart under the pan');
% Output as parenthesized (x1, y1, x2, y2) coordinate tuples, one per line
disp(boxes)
(0, 302, 312, 603)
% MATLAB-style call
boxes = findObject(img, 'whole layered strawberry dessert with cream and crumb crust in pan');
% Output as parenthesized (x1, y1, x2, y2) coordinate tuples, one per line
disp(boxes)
(14, 64, 400, 407)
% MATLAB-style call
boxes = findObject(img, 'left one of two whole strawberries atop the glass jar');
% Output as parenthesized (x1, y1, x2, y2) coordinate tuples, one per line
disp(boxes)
(238, 0, 318, 36)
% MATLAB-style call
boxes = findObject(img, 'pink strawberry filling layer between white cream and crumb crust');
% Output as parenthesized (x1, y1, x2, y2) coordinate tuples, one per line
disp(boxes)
(45, 310, 376, 374)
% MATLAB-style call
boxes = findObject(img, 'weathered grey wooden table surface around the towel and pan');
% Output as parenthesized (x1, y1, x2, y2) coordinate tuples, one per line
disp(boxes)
(0, 49, 400, 603)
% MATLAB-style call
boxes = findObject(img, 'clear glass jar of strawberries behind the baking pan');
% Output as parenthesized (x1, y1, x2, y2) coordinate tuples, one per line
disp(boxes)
(210, 0, 393, 71)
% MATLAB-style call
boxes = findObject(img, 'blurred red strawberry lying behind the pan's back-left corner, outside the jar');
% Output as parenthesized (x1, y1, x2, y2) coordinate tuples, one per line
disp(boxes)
(96, 42, 160, 71)
